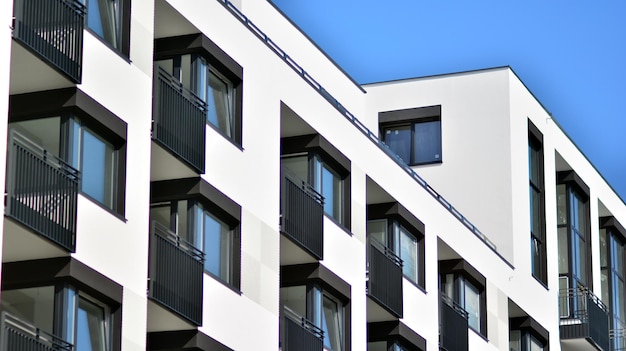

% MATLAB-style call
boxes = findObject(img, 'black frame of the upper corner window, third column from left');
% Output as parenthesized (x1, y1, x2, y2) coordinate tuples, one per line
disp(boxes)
(281, 134, 352, 233)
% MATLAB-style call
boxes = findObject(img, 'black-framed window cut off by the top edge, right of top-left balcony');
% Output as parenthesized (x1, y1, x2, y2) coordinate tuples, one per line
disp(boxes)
(82, 0, 130, 56)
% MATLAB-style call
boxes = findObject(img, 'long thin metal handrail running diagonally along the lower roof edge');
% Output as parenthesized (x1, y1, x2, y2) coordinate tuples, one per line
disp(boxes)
(217, 0, 514, 268)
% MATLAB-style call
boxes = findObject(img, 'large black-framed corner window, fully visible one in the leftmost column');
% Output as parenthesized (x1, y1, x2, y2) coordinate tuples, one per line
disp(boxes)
(9, 88, 127, 216)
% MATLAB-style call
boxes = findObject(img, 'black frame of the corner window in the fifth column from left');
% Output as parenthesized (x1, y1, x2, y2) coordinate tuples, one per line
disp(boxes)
(439, 259, 487, 339)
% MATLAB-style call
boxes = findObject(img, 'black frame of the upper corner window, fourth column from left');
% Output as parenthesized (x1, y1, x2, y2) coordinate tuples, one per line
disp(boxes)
(367, 202, 426, 291)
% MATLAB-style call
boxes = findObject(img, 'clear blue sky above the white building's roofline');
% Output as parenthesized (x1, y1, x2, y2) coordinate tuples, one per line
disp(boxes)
(273, 0, 626, 200)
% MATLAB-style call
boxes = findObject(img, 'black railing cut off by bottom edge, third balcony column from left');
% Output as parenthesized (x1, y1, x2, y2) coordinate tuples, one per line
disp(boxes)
(283, 307, 324, 351)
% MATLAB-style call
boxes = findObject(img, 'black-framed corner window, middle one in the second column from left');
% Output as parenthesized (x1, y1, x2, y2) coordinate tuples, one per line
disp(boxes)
(150, 178, 241, 289)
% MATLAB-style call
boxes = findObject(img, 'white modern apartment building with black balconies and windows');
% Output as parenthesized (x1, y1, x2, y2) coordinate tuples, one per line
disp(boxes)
(0, 0, 626, 351)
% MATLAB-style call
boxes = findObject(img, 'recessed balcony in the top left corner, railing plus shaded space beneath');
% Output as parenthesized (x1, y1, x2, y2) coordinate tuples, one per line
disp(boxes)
(11, 0, 85, 92)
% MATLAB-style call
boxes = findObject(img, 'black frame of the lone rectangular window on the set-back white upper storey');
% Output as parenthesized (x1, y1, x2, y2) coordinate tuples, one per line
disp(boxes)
(378, 105, 443, 166)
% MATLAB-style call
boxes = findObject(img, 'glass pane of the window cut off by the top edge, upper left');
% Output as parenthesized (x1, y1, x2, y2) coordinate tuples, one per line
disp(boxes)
(83, 0, 122, 49)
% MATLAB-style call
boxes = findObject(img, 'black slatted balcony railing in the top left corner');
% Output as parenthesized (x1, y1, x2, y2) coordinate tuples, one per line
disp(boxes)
(13, 0, 85, 83)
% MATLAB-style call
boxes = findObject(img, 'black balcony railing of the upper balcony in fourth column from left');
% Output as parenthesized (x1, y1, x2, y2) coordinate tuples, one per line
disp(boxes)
(367, 238, 403, 318)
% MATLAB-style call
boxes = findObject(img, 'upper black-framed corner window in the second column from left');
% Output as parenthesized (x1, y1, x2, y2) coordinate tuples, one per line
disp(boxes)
(155, 34, 243, 145)
